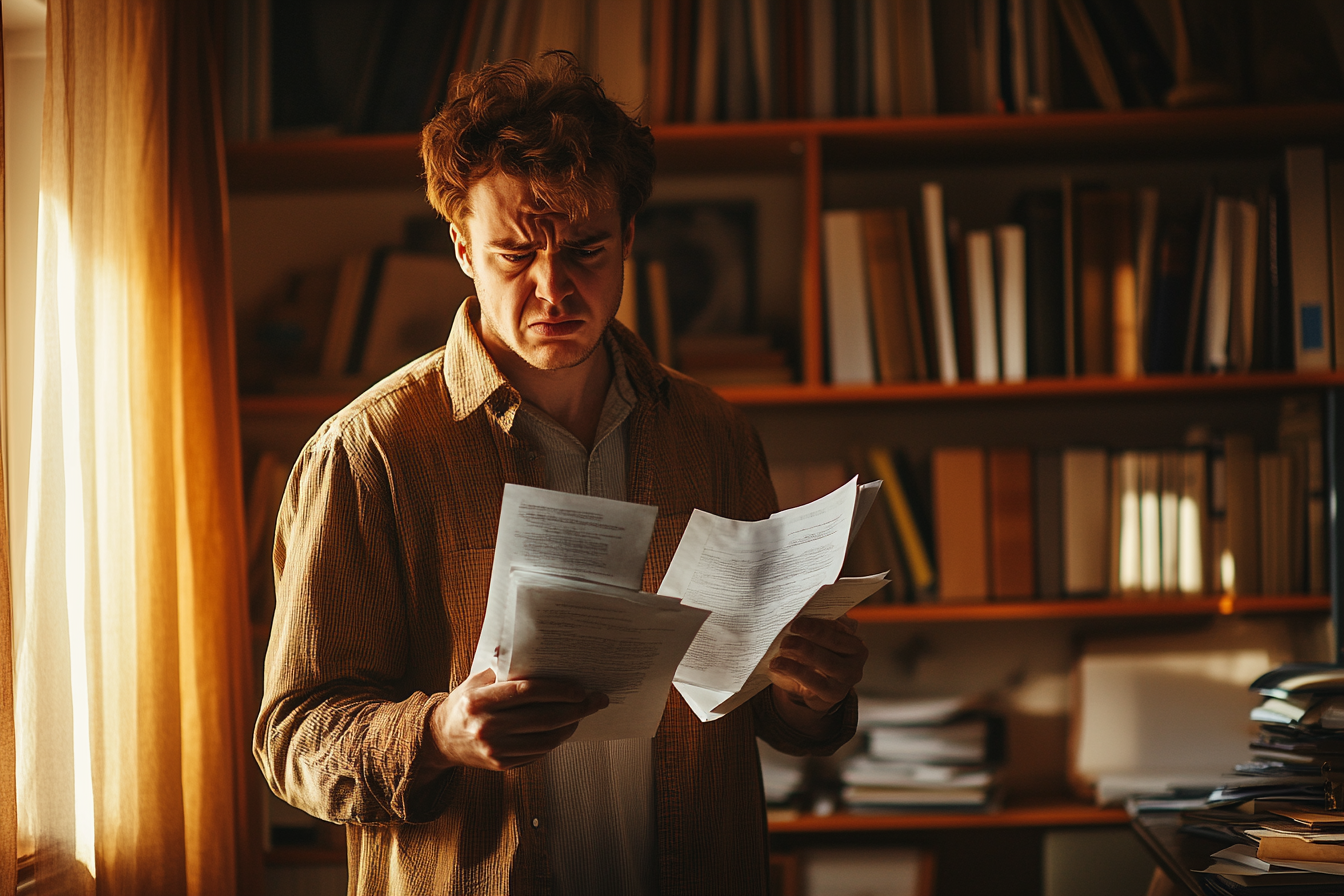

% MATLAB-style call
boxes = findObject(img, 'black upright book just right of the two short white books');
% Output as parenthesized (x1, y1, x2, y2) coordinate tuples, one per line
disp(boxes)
(1013, 189, 1064, 377)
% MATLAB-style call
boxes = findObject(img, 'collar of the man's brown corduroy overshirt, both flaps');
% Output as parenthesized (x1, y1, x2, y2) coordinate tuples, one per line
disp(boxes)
(444, 296, 668, 430)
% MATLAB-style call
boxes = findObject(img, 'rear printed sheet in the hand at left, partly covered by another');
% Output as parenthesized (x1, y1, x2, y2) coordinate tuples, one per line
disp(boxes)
(472, 482, 659, 674)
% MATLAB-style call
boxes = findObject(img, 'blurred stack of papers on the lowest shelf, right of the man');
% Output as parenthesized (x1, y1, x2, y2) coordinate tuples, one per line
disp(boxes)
(840, 697, 1003, 811)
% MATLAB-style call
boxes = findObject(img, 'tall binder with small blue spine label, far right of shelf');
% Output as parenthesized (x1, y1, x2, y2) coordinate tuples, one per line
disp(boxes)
(1285, 146, 1332, 371)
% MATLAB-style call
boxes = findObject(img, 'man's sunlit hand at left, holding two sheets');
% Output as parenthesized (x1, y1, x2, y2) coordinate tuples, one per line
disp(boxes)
(419, 669, 610, 771)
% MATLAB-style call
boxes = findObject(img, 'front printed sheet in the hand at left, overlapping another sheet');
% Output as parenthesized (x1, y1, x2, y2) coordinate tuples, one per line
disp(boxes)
(501, 568, 710, 742)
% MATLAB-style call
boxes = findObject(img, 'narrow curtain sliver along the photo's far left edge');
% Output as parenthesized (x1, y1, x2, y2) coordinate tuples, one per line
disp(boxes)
(0, 24, 19, 893)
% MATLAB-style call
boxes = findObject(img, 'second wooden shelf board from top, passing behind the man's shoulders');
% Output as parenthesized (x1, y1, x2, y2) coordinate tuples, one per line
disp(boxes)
(238, 372, 1344, 416)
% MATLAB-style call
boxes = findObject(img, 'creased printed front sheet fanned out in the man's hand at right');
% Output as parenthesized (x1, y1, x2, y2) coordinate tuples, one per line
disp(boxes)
(659, 480, 857, 692)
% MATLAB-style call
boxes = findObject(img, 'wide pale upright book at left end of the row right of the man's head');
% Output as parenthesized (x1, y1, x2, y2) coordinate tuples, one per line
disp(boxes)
(821, 210, 875, 384)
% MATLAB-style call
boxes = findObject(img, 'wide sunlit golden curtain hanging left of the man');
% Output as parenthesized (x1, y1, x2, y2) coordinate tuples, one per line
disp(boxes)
(17, 0, 255, 895)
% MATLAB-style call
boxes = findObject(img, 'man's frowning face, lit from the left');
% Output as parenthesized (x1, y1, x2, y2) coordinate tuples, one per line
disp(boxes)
(453, 173, 634, 373)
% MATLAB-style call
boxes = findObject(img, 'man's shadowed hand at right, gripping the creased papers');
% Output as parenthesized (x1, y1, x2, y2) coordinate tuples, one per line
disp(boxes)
(770, 617, 868, 735)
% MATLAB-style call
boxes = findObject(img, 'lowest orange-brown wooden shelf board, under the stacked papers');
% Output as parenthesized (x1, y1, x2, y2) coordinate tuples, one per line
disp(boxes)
(770, 799, 1129, 834)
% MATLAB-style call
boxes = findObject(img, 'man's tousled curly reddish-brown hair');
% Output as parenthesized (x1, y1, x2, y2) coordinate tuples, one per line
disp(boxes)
(421, 50, 655, 235)
